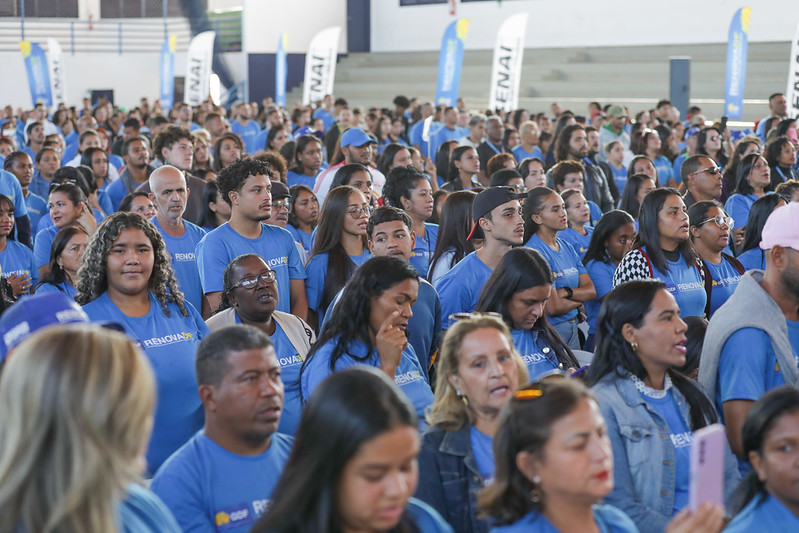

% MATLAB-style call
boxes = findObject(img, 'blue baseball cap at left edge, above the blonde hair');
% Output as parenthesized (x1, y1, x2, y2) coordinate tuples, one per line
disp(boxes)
(0, 292, 89, 360)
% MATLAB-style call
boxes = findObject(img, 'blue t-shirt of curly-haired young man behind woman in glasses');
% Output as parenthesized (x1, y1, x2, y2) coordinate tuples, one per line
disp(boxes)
(196, 222, 305, 313)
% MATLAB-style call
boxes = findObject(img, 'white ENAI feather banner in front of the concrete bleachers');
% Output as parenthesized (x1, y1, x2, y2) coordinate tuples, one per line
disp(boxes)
(488, 13, 527, 111)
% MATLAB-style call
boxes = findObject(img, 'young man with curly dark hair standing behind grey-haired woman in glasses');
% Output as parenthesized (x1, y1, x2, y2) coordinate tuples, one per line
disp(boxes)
(196, 158, 308, 320)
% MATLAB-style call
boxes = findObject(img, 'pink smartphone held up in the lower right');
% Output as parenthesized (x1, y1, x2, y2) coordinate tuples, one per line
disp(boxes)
(688, 424, 727, 512)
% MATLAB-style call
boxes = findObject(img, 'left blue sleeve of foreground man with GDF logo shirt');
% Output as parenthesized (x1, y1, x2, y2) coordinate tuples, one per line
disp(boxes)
(151, 456, 216, 533)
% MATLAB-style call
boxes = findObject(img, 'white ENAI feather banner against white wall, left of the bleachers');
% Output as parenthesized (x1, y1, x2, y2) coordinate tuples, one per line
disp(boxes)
(302, 26, 341, 105)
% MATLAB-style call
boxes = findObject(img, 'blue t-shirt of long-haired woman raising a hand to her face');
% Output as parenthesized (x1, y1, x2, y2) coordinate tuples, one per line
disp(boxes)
(300, 337, 433, 430)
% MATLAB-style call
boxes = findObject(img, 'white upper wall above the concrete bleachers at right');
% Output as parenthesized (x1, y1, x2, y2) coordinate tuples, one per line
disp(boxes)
(371, 0, 799, 51)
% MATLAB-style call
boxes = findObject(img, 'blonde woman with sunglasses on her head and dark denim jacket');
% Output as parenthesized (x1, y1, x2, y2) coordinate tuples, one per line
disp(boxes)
(416, 314, 529, 533)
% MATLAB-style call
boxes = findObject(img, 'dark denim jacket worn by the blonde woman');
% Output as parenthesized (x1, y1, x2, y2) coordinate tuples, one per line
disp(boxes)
(416, 424, 489, 533)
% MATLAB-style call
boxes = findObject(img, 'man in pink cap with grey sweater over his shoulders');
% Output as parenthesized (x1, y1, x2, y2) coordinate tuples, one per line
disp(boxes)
(699, 202, 799, 471)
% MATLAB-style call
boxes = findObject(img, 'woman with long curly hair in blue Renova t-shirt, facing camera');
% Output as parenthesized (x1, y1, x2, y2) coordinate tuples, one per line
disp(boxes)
(75, 212, 208, 475)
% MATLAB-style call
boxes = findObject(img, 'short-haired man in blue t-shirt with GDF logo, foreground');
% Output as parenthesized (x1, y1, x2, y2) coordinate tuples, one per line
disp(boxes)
(152, 325, 293, 533)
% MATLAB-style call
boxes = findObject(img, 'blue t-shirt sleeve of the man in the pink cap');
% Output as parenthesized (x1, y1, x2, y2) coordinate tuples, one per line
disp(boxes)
(718, 328, 774, 402)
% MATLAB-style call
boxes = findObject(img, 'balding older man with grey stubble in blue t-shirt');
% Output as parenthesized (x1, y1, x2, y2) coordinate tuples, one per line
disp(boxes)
(149, 165, 211, 312)
